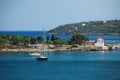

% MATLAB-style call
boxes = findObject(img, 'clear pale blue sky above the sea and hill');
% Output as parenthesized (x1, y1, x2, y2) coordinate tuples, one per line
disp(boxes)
(0, 0, 120, 31)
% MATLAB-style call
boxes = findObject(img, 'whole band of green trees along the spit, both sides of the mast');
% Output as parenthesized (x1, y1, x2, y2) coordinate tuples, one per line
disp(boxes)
(0, 34, 88, 49)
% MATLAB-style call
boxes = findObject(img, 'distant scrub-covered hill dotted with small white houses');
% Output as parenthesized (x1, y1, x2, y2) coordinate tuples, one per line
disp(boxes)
(48, 20, 120, 35)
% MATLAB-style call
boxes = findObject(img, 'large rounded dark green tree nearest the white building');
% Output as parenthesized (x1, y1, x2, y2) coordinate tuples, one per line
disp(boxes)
(68, 34, 89, 45)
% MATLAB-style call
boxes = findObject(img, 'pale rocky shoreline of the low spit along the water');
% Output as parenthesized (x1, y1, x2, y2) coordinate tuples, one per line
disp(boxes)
(0, 44, 120, 52)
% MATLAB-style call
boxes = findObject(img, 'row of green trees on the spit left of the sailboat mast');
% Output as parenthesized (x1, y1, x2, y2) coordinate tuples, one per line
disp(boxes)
(0, 34, 44, 49)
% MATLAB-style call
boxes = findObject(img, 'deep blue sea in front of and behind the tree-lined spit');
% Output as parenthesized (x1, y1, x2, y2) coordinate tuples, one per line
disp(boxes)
(0, 31, 120, 80)
